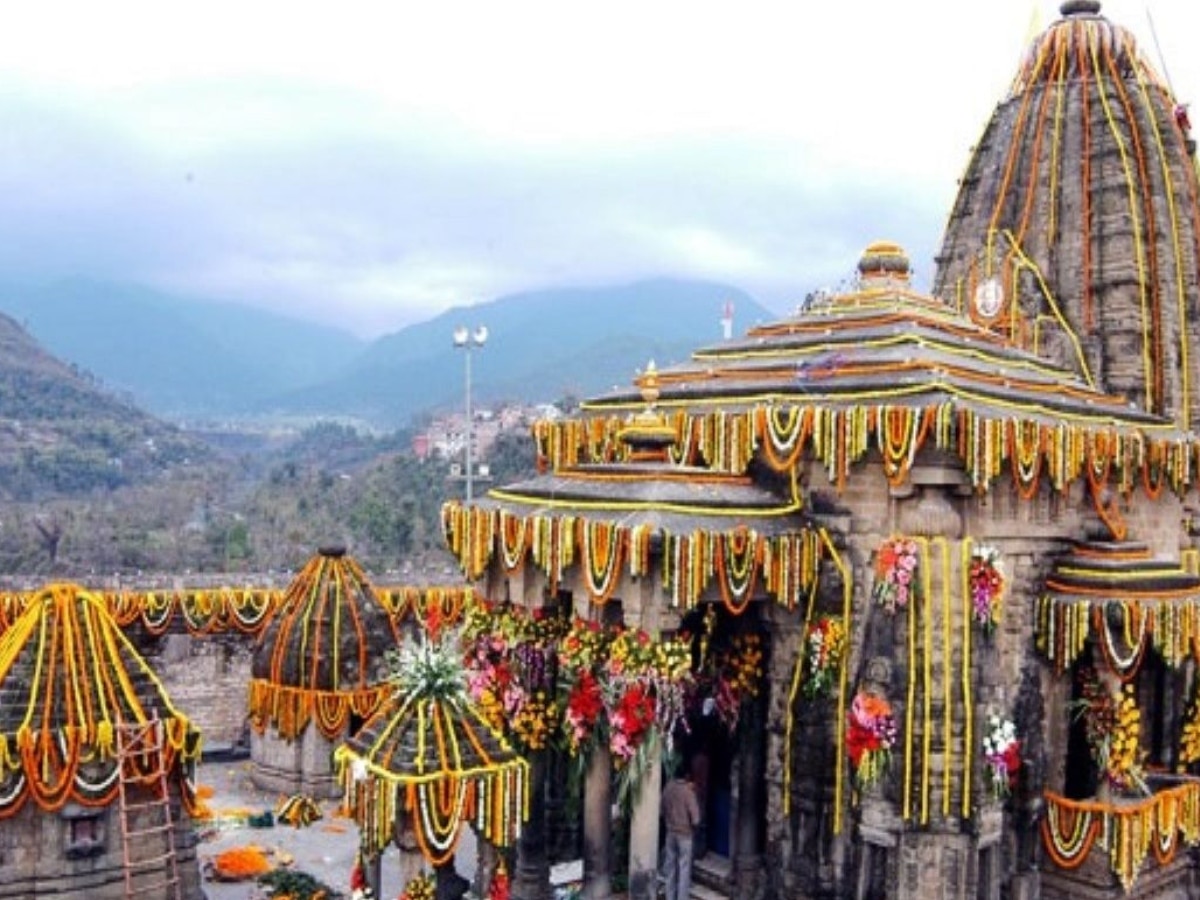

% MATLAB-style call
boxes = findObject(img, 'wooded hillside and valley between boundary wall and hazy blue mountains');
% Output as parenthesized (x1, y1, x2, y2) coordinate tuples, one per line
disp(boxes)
(0, 316, 533, 584)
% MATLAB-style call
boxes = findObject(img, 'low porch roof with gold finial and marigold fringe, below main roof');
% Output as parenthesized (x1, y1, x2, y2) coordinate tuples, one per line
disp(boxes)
(443, 364, 820, 612)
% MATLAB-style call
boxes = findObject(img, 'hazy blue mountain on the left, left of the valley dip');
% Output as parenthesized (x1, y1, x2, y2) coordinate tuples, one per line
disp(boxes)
(0, 280, 366, 419)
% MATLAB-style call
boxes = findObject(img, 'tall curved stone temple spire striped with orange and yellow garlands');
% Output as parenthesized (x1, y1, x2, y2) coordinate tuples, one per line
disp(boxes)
(934, 0, 1200, 430)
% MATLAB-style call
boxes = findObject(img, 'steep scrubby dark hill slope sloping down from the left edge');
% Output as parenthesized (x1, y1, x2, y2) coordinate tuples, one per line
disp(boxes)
(0, 314, 210, 500)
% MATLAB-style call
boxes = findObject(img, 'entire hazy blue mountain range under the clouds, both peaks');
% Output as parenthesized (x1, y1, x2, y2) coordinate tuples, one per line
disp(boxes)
(0, 278, 775, 428)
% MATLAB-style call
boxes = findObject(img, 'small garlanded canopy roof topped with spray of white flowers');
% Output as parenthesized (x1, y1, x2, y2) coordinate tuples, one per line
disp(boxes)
(335, 641, 529, 865)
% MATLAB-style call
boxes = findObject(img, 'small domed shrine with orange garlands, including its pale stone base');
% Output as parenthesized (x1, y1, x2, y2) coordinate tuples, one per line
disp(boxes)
(248, 547, 400, 797)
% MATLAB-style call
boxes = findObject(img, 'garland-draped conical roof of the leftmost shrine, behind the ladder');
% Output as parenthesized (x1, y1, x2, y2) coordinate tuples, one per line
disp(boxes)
(0, 584, 200, 818)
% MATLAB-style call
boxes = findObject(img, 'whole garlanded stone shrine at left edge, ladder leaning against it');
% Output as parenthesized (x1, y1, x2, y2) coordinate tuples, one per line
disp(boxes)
(0, 584, 204, 900)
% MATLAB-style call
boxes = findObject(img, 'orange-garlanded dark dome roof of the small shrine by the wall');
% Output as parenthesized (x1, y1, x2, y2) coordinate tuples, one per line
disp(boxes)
(250, 547, 400, 740)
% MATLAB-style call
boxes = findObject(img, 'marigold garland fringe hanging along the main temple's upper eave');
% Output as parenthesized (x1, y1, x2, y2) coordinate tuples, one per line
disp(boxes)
(534, 403, 1200, 498)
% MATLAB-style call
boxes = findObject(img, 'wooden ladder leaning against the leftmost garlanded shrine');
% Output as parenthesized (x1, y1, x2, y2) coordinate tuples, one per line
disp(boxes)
(115, 718, 184, 900)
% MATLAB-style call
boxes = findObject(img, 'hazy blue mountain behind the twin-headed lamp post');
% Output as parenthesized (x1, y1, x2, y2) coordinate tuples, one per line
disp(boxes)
(263, 280, 776, 427)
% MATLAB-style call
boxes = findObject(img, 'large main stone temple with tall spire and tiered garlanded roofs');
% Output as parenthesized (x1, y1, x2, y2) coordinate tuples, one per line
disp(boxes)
(445, 0, 1200, 899)
